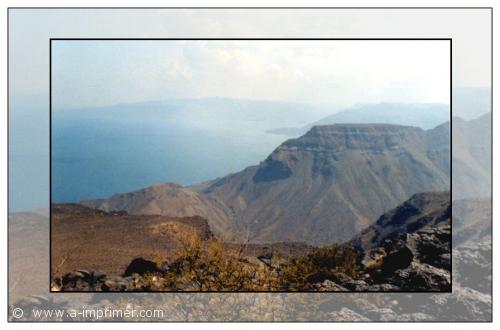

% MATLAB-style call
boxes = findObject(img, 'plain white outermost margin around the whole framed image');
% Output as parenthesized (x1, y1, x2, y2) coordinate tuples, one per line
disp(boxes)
(0, 0, 500, 330)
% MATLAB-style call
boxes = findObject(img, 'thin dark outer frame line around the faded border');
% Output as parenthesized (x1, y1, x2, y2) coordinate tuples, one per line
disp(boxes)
(6, 6, 494, 324)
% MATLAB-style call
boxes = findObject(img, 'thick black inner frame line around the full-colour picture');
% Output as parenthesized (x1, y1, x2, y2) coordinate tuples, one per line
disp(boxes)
(49, 38, 453, 294)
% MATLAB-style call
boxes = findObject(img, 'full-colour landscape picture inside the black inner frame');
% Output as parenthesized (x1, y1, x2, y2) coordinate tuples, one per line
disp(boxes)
(50, 39, 454, 292)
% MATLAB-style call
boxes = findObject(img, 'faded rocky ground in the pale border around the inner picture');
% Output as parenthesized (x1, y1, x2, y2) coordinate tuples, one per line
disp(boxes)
(9, 199, 492, 321)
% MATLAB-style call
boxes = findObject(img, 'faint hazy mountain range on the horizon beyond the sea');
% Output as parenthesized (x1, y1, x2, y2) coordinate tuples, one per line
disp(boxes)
(53, 97, 335, 131)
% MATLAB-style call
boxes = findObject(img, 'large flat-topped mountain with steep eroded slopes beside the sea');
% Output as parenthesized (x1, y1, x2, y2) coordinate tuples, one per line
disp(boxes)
(204, 124, 449, 244)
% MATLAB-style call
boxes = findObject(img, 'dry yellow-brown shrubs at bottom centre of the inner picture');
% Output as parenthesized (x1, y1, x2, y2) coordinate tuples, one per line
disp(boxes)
(146, 227, 358, 291)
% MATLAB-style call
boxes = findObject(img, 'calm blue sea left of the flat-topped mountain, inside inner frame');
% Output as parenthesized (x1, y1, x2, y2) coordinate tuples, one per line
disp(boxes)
(52, 118, 286, 202)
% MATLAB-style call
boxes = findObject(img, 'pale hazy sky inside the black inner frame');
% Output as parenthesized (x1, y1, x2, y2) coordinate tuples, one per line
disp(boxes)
(52, 40, 450, 108)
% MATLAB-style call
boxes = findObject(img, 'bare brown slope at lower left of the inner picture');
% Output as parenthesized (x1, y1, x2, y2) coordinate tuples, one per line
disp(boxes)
(51, 204, 211, 277)
